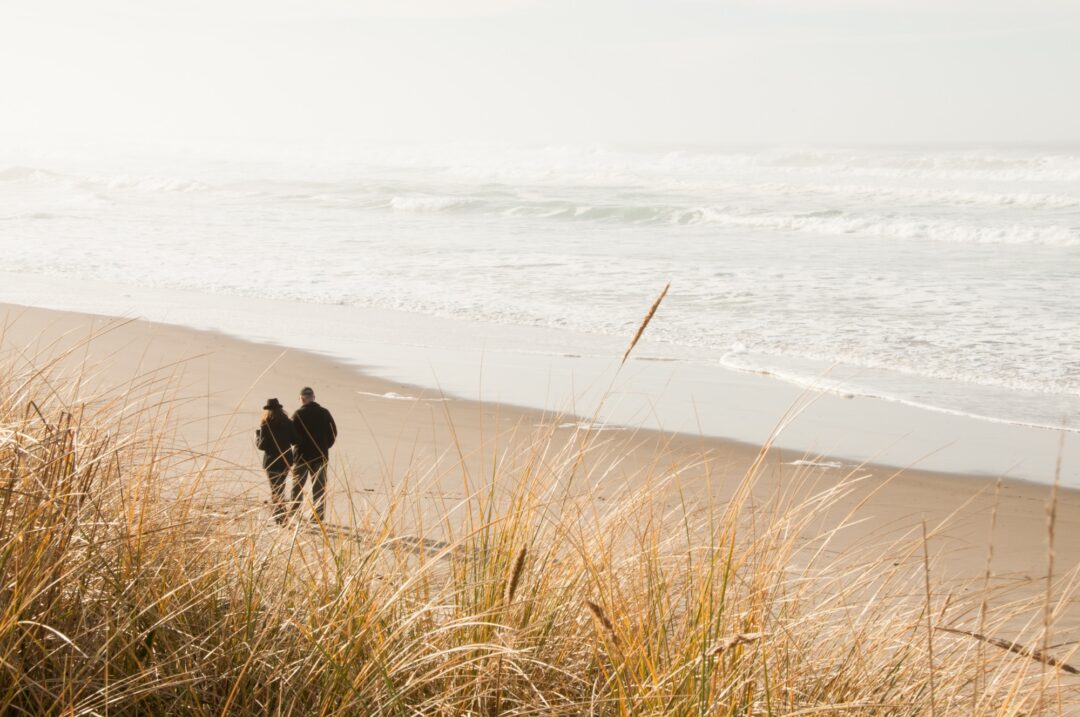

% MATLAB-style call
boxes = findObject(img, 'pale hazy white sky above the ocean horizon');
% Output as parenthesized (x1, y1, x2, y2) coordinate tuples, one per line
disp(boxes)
(0, 0, 1080, 146)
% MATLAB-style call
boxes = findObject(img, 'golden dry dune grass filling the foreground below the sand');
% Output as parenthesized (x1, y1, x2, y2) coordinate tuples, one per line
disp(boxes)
(0, 334, 1080, 716)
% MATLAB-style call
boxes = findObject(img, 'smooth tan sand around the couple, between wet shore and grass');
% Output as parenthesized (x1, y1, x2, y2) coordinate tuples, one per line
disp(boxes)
(2, 306, 1080, 634)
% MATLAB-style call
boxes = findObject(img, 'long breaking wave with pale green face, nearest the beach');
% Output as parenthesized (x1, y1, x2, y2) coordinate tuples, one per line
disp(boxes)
(6, 165, 1080, 247)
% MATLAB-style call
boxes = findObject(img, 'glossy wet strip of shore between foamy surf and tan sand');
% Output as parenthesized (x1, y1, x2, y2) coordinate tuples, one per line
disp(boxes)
(0, 272, 1080, 488)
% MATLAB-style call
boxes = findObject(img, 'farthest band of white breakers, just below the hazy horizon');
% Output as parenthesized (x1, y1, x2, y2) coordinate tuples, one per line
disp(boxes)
(8, 145, 1080, 193)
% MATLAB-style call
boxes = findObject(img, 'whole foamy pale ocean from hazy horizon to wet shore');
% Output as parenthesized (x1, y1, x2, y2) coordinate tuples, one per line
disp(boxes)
(0, 138, 1080, 430)
